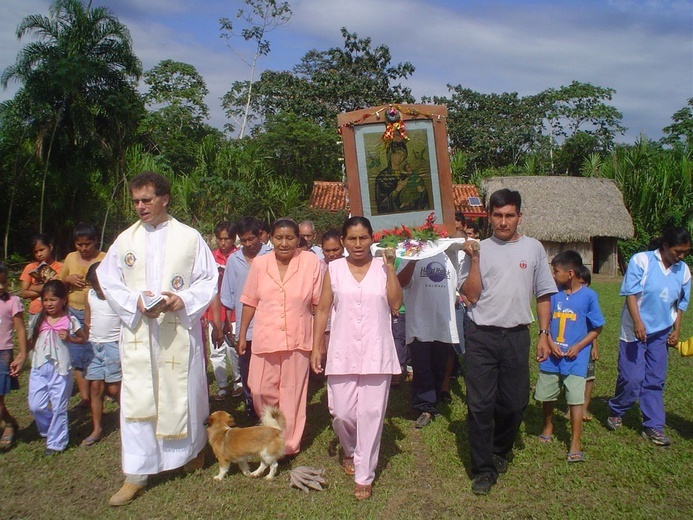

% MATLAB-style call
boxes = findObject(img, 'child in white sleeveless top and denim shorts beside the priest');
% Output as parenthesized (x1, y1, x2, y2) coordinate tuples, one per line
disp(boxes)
(82, 262, 123, 447)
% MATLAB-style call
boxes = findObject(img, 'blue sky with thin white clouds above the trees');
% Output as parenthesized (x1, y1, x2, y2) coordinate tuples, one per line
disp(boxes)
(0, 0, 693, 142)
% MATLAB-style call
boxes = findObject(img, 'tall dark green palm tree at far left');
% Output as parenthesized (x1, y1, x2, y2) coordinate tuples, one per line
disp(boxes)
(1, 0, 143, 256)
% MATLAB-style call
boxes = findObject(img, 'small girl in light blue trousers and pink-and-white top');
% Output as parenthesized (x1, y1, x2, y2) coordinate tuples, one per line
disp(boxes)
(29, 280, 87, 455)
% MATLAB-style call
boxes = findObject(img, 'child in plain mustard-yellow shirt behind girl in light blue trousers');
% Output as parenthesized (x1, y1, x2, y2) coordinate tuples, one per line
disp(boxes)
(60, 222, 106, 410)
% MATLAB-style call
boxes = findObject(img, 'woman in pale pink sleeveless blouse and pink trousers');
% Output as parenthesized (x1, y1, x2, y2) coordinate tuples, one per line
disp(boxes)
(311, 217, 402, 500)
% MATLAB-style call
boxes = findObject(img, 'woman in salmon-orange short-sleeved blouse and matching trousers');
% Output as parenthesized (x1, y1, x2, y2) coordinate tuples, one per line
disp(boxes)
(238, 219, 322, 455)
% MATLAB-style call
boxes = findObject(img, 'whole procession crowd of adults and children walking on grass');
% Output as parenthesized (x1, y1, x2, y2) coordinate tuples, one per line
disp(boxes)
(0, 172, 691, 506)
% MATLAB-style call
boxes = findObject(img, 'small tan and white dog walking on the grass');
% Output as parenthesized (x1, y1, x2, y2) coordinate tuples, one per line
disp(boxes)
(205, 406, 286, 480)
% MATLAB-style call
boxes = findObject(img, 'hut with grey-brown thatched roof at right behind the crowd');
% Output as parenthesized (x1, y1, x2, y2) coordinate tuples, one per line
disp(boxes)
(481, 176, 634, 274)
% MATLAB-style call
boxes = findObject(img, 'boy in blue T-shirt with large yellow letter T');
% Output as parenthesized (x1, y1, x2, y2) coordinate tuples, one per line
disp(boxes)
(534, 251, 604, 462)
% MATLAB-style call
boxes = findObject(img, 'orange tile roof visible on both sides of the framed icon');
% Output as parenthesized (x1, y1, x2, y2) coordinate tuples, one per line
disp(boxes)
(310, 181, 486, 217)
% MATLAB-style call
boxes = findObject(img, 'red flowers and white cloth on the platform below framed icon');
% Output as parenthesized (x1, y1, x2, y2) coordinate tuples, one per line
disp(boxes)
(373, 212, 465, 260)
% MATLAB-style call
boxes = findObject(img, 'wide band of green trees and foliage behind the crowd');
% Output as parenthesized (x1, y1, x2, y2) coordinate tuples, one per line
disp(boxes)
(0, 0, 693, 257)
